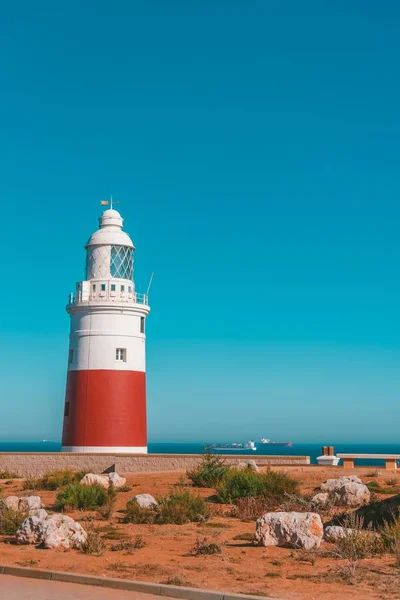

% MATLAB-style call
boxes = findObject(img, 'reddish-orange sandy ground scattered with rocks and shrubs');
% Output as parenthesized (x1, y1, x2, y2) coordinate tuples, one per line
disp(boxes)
(0, 467, 400, 600)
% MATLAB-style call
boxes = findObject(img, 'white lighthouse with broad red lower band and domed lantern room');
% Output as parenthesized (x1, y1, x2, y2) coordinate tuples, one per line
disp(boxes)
(62, 202, 150, 453)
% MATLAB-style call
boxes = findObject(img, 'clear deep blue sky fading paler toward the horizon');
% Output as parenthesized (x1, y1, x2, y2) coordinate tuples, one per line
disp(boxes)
(0, 0, 400, 443)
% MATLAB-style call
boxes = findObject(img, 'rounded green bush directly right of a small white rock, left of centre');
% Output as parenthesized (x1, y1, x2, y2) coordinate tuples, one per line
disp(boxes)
(156, 492, 210, 525)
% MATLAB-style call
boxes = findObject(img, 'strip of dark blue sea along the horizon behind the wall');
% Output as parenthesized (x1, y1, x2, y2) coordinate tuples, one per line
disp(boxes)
(0, 442, 400, 467)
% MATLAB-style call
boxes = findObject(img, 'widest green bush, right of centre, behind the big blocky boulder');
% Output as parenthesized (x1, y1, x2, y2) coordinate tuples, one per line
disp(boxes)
(217, 469, 299, 505)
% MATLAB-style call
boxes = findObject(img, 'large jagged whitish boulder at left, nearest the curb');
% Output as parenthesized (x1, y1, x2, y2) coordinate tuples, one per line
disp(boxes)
(16, 511, 87, 549)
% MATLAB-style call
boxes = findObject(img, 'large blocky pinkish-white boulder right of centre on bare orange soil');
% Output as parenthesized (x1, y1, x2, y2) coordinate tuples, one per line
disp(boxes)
(255, 512, 324, 550)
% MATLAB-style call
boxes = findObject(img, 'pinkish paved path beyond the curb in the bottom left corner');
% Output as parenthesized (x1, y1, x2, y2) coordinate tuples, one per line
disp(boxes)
(0, 575, 172, 600)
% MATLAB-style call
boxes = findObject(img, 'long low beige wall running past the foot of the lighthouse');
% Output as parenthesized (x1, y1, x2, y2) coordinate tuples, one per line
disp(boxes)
(0, 452, 310, 477)
